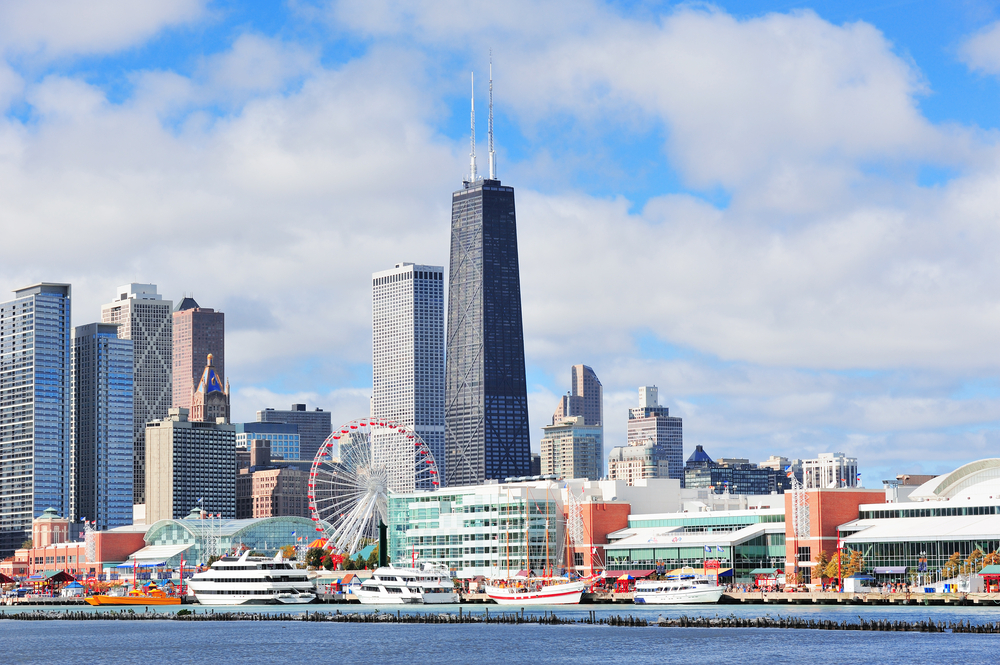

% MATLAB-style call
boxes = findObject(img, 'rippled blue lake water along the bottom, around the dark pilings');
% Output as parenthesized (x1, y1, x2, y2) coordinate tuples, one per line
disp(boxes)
(0, 605, 1000, 665)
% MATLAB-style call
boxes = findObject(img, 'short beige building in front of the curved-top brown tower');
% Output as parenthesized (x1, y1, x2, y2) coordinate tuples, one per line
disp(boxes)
(541, 416, 604, 480)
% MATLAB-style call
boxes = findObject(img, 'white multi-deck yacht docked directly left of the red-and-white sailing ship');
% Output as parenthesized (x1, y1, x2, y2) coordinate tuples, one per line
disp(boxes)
(353, 563, 459, 605)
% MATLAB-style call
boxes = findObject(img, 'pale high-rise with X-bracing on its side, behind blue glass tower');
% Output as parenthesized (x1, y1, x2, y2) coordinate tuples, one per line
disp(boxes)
(101, 284, 174, 504)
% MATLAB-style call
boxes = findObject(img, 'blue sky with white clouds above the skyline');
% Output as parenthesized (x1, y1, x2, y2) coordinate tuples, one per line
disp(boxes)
(0, 0, 1000, 487)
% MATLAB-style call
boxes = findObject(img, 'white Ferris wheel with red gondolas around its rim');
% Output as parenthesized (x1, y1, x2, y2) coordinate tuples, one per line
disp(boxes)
(308, 418, 440, 556)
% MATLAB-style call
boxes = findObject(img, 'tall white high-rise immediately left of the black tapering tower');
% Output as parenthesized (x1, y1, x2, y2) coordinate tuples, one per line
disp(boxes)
(371, 263, 445, 491)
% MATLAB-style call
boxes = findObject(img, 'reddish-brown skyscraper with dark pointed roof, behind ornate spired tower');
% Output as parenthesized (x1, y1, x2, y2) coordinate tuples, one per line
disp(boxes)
(172, 297, 226, 409)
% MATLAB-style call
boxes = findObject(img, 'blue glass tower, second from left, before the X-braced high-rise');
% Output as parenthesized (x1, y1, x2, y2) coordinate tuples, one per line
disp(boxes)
(73, 323, 134, 530)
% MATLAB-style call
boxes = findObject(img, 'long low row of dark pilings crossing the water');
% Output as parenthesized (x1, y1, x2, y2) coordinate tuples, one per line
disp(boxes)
(0, 608, 1000, 634)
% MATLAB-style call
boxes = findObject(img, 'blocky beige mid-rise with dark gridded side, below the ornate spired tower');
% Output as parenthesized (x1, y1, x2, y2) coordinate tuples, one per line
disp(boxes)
(146, 409, 236, 524)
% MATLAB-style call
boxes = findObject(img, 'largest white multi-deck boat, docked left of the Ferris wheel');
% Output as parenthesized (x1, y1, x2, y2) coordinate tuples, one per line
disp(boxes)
(188, 552, 315, 605)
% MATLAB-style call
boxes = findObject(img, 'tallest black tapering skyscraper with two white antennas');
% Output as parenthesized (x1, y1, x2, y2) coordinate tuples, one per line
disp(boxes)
(445, 66, 530, 485)
